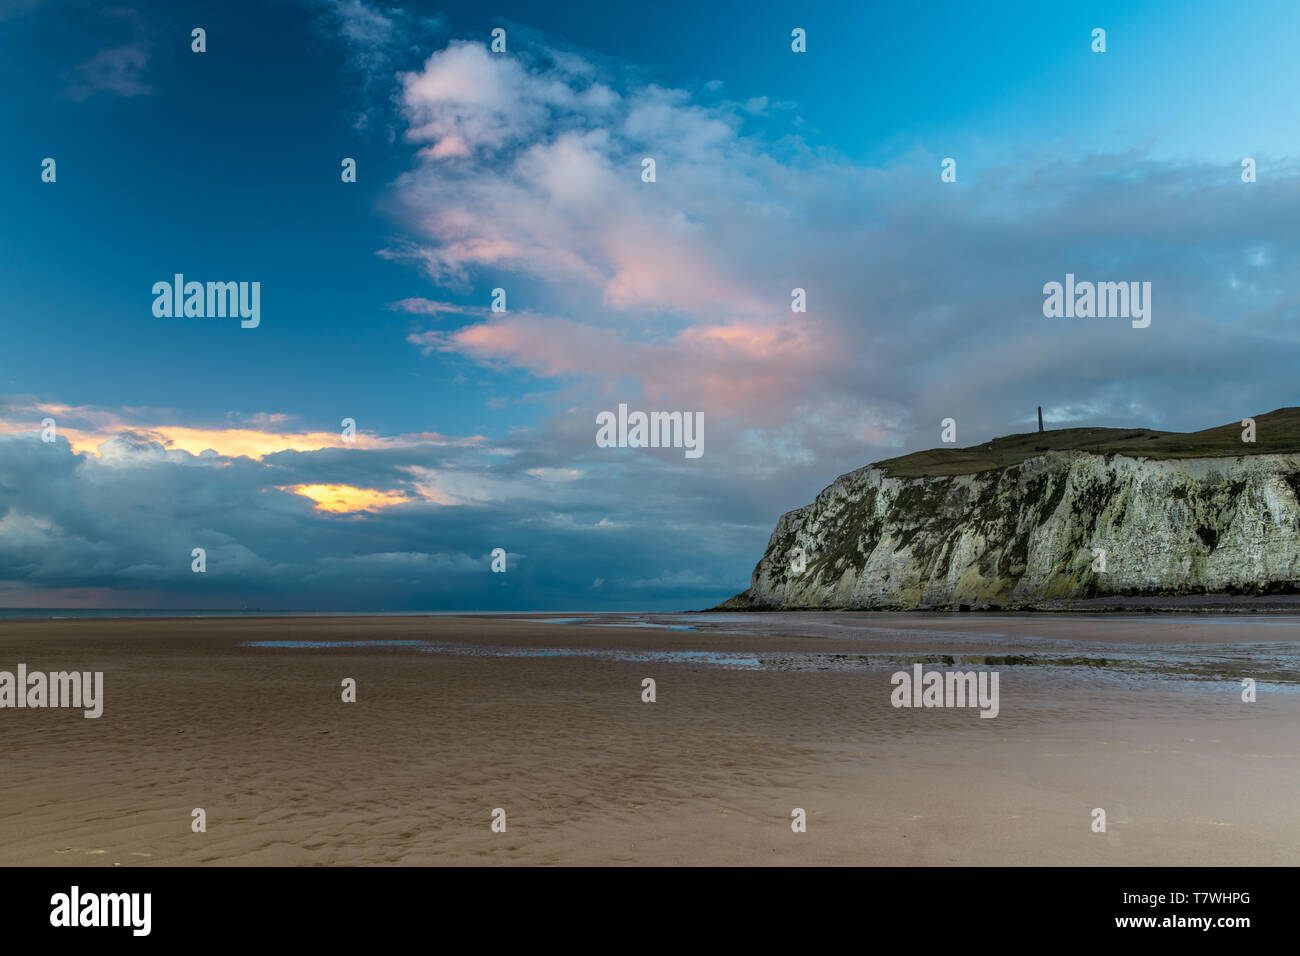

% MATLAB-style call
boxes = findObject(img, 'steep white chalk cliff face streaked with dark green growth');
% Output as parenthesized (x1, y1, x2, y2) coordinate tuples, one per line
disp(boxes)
(748, 451, 1300, 607)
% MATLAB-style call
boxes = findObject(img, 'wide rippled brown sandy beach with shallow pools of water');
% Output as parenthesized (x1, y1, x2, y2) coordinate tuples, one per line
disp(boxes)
(0, 614, 1300, 866)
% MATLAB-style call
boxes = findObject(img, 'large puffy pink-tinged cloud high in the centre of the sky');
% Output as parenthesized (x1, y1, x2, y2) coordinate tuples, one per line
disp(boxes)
(390, 37, 904, 455)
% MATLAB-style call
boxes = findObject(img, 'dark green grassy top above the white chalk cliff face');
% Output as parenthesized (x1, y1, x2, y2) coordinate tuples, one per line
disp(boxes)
(875, 407, 1300, 477)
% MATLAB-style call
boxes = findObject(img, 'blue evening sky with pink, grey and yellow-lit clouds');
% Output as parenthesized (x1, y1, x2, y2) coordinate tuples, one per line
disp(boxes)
(0, 0, 1300, 610)
